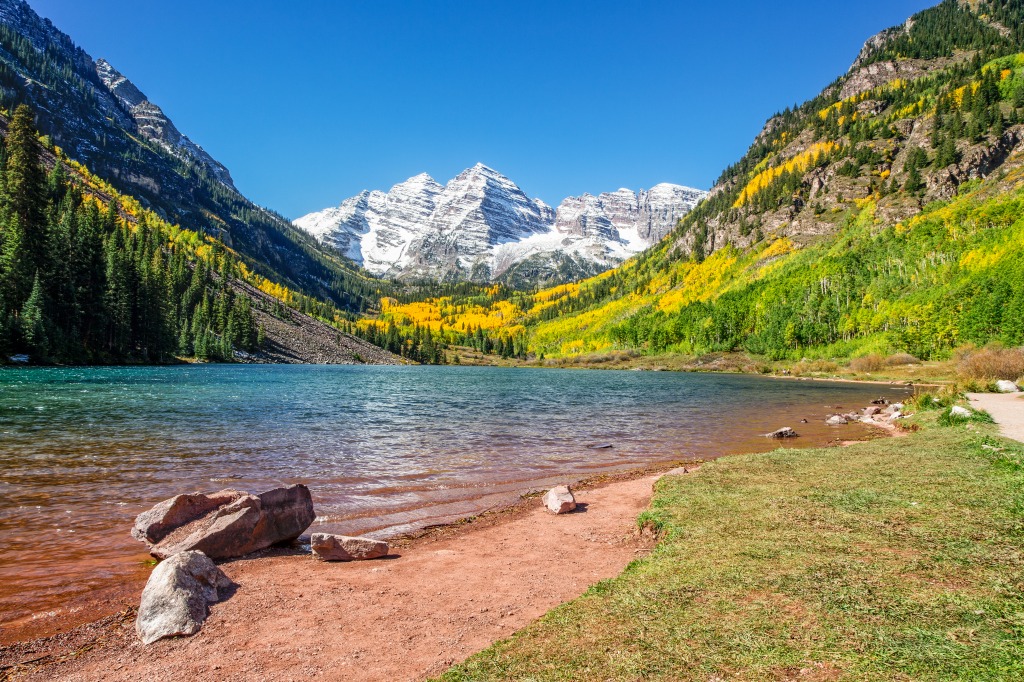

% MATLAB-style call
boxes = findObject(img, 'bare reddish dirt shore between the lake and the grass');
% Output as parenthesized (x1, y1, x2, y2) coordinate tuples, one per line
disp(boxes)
(0, 476, 654, 681)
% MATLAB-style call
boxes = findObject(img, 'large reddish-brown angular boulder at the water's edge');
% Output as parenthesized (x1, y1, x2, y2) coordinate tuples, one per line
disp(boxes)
(132, 477, 316, 559)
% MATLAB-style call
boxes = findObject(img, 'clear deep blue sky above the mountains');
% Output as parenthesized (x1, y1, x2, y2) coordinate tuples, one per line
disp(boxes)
(29, 0, 938, 218)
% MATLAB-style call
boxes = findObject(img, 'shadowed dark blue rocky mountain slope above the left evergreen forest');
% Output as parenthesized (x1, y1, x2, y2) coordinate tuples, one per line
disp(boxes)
(0, 0, 380, 310)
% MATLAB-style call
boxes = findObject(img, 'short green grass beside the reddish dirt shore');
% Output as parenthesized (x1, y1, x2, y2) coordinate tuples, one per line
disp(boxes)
(440, 411, 1024, 682)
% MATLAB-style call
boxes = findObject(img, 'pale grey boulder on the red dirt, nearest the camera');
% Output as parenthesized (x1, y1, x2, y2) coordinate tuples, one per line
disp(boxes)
(135, 552, 231, 644)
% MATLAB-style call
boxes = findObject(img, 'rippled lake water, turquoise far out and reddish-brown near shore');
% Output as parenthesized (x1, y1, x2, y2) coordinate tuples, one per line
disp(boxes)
(0, 366, 905, 625)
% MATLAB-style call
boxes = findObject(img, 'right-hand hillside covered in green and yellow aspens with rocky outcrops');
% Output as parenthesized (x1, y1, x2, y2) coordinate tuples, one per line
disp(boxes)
(370, 0, 1024, 366)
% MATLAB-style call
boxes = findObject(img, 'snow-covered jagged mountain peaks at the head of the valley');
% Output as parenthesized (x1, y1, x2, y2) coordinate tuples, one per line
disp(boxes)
(295, 164, 706, 282)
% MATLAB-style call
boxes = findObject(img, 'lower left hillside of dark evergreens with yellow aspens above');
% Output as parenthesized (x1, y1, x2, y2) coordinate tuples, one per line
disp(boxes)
(0, 104, 396, 364)
